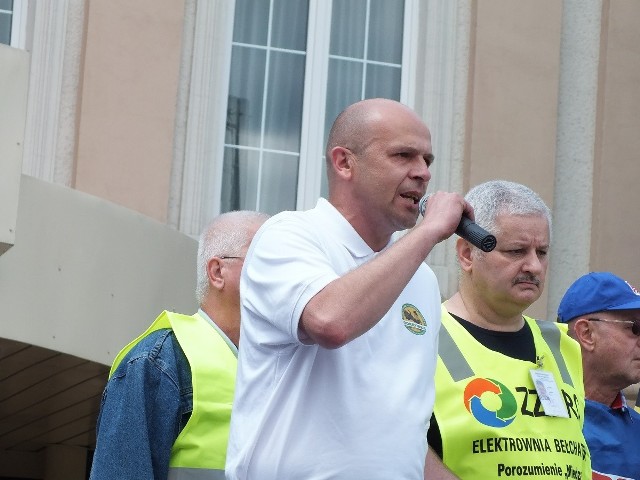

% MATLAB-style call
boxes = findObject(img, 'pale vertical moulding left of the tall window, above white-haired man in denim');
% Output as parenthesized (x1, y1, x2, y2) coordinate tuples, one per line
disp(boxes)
(175, 0, 235, 236)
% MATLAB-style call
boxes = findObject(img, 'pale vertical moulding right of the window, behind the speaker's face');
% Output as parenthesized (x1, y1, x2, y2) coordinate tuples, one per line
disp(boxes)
(415, 0, 471, 297)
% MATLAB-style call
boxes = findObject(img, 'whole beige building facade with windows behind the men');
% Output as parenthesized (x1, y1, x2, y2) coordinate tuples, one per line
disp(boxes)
(0, 0, 640, 479)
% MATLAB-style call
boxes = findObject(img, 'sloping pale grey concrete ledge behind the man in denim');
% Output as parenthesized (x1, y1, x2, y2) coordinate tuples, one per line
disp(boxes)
(0, 175, 197, 365)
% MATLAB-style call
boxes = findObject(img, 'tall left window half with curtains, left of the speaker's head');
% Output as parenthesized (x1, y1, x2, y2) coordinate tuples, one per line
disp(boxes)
(221, 0, 309, 213)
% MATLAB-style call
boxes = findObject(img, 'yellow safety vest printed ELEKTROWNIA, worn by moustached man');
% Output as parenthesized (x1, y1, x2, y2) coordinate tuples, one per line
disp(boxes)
(427, 306, 591, 480)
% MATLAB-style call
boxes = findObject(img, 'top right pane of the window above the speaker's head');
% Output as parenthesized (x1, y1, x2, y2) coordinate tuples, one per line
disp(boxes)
(367, 0, 404, 64)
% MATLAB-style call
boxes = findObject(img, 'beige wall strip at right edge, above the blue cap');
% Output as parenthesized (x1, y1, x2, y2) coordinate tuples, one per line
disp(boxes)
(592, 0, 640, 287)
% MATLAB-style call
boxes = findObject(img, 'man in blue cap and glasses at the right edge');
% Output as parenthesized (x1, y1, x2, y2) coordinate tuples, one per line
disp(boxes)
(558, 272, 640, 479)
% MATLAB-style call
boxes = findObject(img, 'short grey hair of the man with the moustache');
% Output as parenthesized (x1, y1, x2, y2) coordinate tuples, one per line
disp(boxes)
(464, 180, 551, 241)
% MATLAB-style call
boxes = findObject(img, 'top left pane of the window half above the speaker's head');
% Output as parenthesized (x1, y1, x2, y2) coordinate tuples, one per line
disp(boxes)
(329, 0, 367, 58)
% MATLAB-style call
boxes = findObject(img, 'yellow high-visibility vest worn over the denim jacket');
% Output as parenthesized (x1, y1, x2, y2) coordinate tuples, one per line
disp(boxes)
(109, 311, 238, 480)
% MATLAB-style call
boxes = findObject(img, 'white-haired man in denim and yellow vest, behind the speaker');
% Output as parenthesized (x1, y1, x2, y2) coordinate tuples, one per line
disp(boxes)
(89, 210, 269, 480)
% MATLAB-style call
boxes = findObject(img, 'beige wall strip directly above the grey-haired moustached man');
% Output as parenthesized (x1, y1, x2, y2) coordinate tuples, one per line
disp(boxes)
(463, 0, 562, 318)
